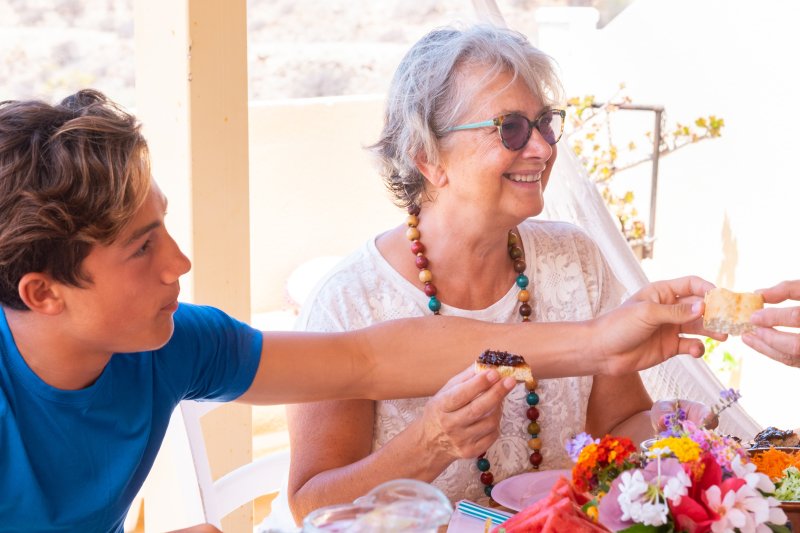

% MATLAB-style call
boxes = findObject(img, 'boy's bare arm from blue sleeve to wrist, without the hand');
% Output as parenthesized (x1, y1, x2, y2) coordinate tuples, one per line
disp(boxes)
(240, 317, 600, 404)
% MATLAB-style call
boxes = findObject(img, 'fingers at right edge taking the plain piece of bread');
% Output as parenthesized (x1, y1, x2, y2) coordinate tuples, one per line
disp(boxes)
(742, 280, 800, 367)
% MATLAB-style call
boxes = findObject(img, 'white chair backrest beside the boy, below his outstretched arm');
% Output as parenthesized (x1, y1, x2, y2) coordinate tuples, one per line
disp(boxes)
(181, 400, 289, 528)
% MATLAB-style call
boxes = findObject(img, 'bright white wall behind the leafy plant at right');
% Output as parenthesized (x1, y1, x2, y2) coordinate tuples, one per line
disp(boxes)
(549, 0, 800, 428)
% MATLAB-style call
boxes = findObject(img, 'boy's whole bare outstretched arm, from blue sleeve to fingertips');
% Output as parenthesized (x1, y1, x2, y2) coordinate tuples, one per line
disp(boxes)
(239, 277, 713, 404)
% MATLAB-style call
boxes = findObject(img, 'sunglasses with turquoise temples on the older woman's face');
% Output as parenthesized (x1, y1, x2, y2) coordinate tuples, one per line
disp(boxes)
(446, 109, 567, 151)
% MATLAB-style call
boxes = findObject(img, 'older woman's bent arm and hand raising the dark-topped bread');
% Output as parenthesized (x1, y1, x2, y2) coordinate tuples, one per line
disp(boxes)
(287, 368, 514, 522)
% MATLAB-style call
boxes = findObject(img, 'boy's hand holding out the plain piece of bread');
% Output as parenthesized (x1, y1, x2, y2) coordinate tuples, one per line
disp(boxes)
(594, 276, 727, 376)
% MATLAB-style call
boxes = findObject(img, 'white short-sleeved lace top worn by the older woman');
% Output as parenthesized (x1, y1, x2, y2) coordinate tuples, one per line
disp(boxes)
(297, 220, 625, 501)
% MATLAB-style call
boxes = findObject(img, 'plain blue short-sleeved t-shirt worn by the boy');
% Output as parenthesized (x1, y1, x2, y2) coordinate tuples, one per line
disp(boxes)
(0, 304, 262, 532)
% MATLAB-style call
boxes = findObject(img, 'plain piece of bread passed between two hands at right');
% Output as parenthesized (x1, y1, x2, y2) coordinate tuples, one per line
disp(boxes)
(703, 288, 764, 335)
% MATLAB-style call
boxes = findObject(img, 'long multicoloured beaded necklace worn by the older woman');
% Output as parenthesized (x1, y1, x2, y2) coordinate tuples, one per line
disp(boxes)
(406, 205, 542, 503)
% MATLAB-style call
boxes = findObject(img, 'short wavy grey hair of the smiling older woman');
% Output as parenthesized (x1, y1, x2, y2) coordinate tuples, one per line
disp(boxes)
(368, 24, 563, 208)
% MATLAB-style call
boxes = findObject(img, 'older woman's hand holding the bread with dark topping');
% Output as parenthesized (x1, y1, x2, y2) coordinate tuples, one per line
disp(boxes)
(420, 367, 516, 464)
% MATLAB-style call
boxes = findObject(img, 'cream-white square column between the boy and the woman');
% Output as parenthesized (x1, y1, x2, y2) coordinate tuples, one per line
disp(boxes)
(132, 0, 252, 531)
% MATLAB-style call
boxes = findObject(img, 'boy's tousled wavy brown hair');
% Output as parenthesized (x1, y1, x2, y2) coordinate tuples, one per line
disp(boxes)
(0, 89, 150, 310)
